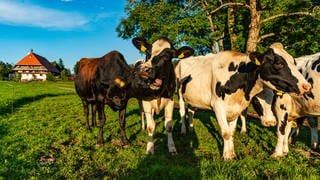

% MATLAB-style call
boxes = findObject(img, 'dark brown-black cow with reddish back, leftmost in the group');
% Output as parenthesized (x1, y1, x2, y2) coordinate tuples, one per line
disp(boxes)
(75, 51, 155, 146)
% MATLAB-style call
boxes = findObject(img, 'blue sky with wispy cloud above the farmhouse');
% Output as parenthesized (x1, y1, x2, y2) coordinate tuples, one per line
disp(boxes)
(0, 0, 142, 70)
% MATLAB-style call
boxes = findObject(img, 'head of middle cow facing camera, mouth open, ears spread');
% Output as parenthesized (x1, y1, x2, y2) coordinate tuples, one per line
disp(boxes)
(132, 37, 194, 90)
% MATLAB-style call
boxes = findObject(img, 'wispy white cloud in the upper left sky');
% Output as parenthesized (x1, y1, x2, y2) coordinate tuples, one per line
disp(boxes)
(0, 0, 89, 29)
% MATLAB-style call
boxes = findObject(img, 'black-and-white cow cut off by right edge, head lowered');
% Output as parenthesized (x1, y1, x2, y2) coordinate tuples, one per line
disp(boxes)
(253, 53, 320, 157)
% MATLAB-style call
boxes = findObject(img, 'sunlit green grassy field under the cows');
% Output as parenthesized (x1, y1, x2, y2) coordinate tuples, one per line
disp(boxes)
(0, 81, 320, 179)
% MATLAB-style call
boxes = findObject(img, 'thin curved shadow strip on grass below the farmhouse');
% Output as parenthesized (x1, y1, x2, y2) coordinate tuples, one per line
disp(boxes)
(0, 93, 74, 116)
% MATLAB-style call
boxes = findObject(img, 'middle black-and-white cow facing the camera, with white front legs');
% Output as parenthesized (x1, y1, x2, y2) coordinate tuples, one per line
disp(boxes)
(133, 37, 194, 155)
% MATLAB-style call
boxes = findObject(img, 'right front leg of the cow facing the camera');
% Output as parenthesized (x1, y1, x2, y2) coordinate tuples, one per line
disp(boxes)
(164, 100, 177, 155)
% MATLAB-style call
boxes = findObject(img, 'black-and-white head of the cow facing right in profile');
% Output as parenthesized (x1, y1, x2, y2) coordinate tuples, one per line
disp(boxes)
(249, 43, 311, 94)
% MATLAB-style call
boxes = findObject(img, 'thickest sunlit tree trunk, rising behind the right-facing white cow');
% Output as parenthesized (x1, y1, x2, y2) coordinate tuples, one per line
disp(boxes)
(246, 0, 260, 53)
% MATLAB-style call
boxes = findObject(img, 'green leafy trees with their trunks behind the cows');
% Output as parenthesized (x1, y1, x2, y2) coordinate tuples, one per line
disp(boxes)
(116, 0, 320, 56)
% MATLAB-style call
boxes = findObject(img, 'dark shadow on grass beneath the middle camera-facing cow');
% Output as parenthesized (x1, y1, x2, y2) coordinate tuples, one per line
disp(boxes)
(118, 108, 200, 179)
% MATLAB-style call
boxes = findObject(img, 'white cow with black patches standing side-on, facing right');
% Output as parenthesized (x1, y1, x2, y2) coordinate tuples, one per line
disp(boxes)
(175, 43, 311, 160)
